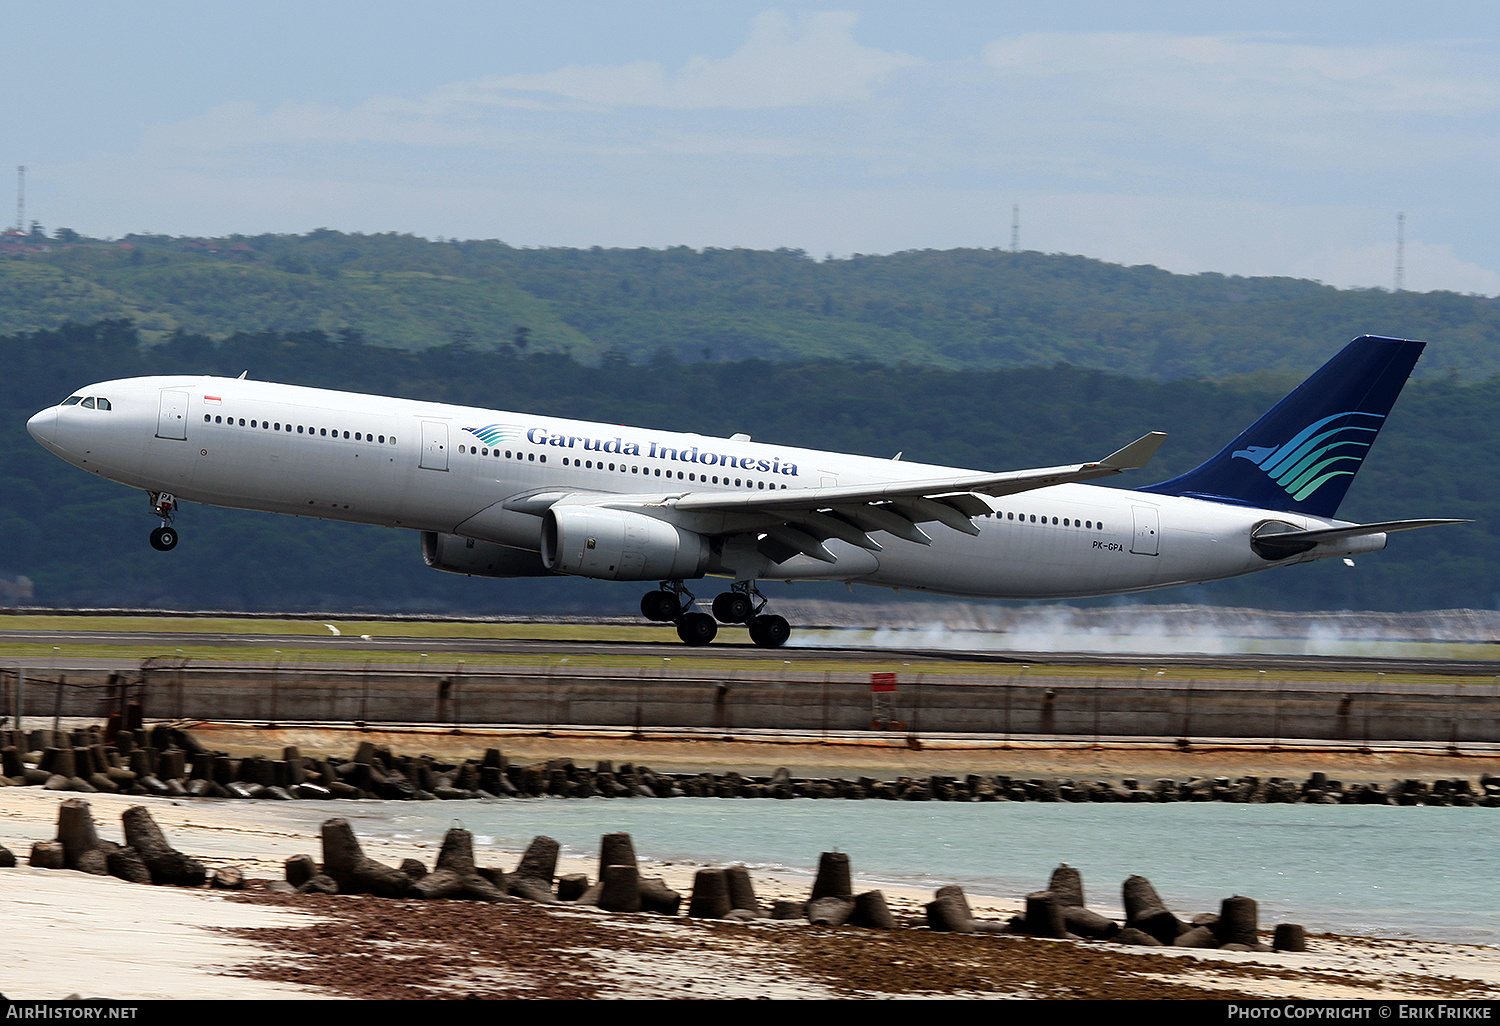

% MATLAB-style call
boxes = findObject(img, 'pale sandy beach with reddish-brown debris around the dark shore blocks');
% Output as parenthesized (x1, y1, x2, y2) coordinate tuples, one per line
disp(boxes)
(0, 735, 1500, 1001)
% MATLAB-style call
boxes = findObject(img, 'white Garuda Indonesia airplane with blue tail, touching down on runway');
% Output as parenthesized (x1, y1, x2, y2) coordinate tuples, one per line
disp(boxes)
(27, 336, 1464, 648)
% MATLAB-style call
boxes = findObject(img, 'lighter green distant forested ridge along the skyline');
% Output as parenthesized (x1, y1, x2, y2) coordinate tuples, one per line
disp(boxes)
(0, 230, 1500, 381)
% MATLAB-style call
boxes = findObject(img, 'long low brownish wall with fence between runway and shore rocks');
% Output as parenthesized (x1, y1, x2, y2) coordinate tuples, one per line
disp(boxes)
(0, 662, 1500, 746)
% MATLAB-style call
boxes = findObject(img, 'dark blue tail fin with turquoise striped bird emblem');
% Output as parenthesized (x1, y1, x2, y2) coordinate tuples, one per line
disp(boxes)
(1136, 335, 1427, 518)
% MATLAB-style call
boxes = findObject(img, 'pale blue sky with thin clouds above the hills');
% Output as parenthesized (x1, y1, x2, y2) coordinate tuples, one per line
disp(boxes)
(0, 0, 1500, 296)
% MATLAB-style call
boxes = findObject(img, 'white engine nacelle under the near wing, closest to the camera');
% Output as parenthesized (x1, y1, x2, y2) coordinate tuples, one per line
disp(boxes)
(542, 506, 710, 581)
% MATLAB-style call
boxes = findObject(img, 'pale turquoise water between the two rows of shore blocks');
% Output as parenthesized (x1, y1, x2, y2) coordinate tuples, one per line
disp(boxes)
(339, 798, 1500, 945)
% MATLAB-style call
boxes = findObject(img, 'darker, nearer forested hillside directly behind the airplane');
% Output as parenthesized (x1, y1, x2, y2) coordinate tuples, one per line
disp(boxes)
(0, 321, 1500, 614)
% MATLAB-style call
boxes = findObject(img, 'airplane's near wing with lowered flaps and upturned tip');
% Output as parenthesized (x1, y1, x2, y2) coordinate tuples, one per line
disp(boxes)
(639, 431, 1166, 563)
